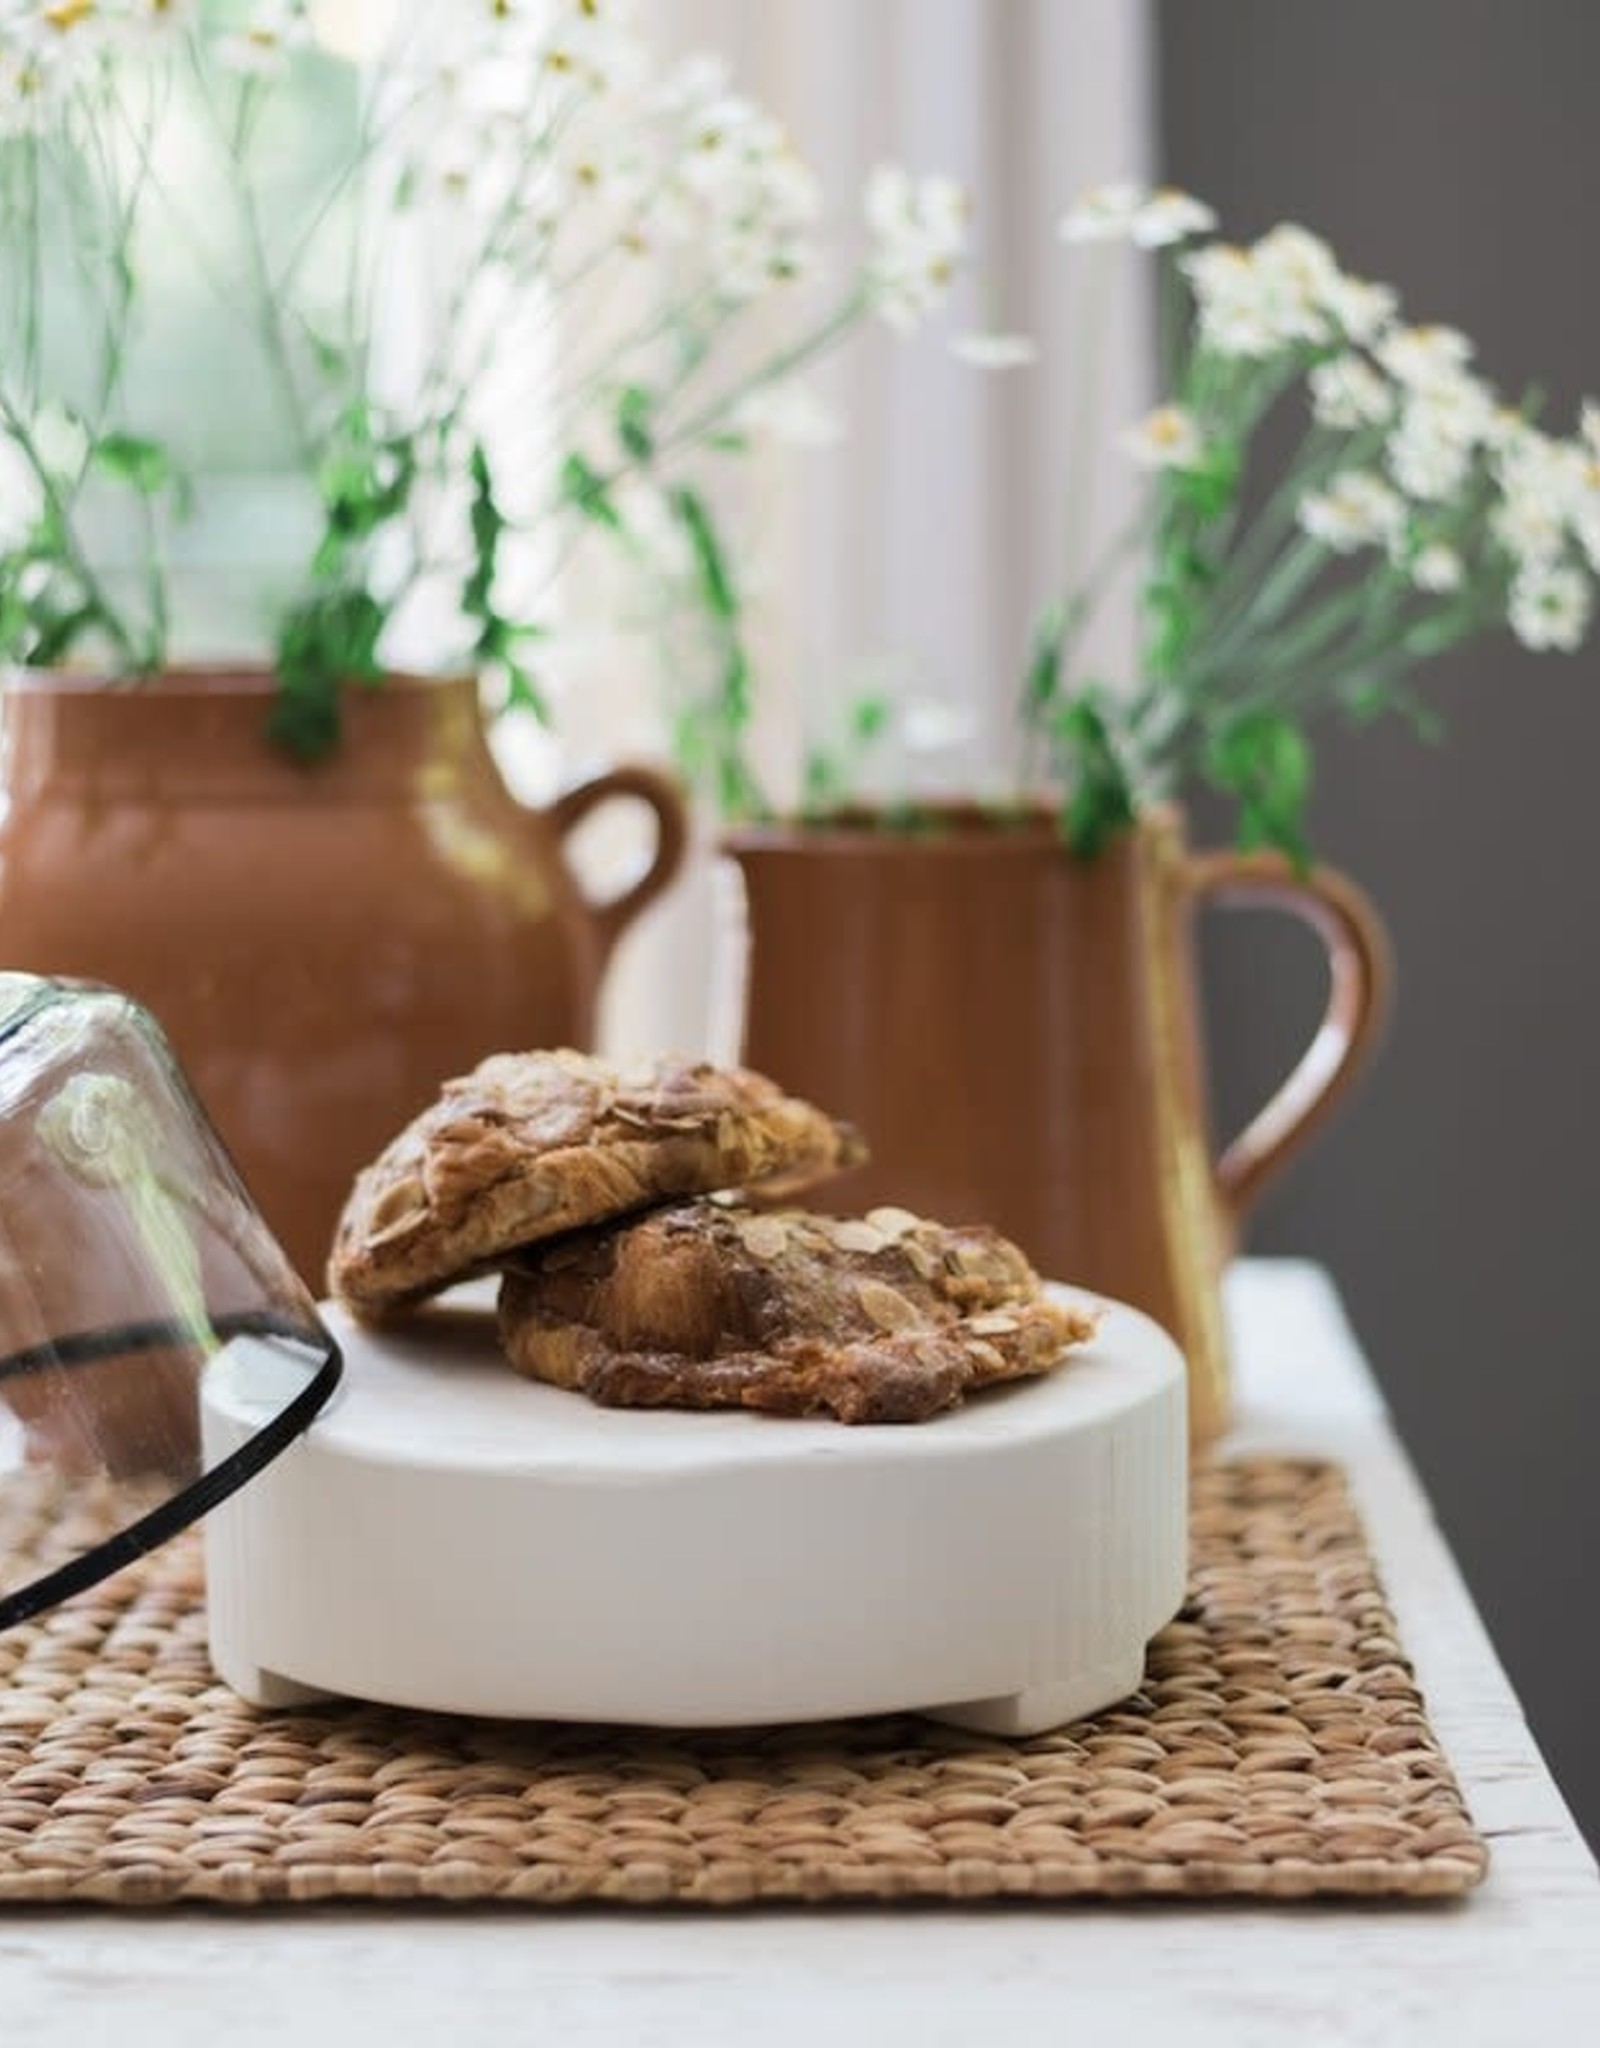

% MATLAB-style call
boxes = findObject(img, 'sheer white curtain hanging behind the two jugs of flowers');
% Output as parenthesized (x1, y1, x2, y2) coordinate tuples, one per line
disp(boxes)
(570, 0, 1153, 1055)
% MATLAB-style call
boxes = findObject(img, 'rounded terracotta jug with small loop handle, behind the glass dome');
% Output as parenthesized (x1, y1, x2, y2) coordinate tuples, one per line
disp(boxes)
(0, 670, 684, 1288)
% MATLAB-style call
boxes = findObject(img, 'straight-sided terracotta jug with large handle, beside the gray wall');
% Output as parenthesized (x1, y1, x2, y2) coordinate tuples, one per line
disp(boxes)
(727, 809, 1387, 1442)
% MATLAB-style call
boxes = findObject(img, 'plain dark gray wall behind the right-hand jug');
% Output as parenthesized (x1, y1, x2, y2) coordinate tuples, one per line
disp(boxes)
(1157, 0, 1600, 1839)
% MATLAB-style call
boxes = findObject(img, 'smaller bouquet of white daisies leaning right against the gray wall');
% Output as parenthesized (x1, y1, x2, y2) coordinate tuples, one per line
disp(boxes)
(1020, 186, 1600, 860)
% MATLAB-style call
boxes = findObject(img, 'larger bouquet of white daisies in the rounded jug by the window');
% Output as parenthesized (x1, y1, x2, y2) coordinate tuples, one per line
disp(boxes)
(0, 0, 965, 770)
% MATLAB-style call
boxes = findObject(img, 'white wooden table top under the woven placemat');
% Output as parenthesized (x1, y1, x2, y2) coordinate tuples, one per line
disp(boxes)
(0, 1262, 1600, 2048)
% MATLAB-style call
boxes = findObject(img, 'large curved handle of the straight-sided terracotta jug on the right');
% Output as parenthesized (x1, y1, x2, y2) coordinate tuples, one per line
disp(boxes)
(1186, 852, 1391, 1223)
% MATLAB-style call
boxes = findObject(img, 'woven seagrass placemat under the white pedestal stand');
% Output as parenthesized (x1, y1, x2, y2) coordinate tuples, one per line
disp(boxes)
(0, 1460, 1487, 1907)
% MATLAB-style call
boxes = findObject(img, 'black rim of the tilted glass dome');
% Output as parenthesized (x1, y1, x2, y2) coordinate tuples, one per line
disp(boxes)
(0, 1310, 344, 1630)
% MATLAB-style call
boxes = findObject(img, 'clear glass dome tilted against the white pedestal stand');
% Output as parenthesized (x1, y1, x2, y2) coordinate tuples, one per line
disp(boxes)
(0, 973, 340, 1628)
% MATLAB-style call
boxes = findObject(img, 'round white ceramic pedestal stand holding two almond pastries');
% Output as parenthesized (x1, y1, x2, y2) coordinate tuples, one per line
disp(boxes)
(203, 1290, 1186, 1735)
